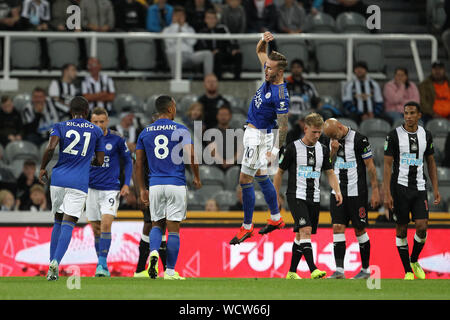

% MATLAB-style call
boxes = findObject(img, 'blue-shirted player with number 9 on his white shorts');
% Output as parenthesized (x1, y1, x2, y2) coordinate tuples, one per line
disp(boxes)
(86, 107, 133, 277)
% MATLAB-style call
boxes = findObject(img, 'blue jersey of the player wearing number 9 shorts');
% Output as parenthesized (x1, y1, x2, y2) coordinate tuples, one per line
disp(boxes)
(89, 129, 133, 190)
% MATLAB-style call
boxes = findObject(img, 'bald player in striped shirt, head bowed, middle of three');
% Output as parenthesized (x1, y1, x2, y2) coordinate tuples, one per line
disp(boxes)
(324, 118, 380, 279)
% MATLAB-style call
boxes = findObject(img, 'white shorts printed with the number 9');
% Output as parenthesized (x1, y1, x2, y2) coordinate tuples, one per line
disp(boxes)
(86, 188, 120, 221)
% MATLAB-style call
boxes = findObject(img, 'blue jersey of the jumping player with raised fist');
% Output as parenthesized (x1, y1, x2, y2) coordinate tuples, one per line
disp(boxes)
(247, 81, 289, 132)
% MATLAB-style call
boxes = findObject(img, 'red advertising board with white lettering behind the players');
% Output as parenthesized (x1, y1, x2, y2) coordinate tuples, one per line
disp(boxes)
(0, 222, 450, 279)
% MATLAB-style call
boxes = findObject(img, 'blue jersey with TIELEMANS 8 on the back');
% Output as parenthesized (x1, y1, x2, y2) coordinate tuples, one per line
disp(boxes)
(136, 119, 192, 186)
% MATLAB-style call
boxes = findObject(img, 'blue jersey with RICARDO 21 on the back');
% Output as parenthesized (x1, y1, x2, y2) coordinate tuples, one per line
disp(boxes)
(50, 118, 105, 193)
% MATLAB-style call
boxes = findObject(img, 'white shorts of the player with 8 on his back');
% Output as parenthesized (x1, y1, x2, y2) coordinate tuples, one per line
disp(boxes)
(149, 185, 187, 221)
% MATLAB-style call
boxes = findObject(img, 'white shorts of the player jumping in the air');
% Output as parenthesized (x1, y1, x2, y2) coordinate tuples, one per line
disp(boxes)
(241, 127, 278, 177)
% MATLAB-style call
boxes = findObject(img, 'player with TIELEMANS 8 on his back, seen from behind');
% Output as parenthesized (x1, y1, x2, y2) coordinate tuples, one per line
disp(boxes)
(136, 95, 201, 280)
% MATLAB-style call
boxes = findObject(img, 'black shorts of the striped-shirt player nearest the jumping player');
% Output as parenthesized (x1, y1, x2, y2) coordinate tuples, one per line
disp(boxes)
(286, 194, 320, 234)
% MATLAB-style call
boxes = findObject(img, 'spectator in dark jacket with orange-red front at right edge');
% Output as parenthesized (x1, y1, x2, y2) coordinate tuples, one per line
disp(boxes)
(419, 61, 450, 122)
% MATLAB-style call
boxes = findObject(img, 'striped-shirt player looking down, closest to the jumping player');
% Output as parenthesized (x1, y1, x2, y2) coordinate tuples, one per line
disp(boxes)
(273, 113, 342, 279)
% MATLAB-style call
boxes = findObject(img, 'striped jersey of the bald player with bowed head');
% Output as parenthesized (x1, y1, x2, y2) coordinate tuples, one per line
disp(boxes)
(330, 127, 372, 197)
